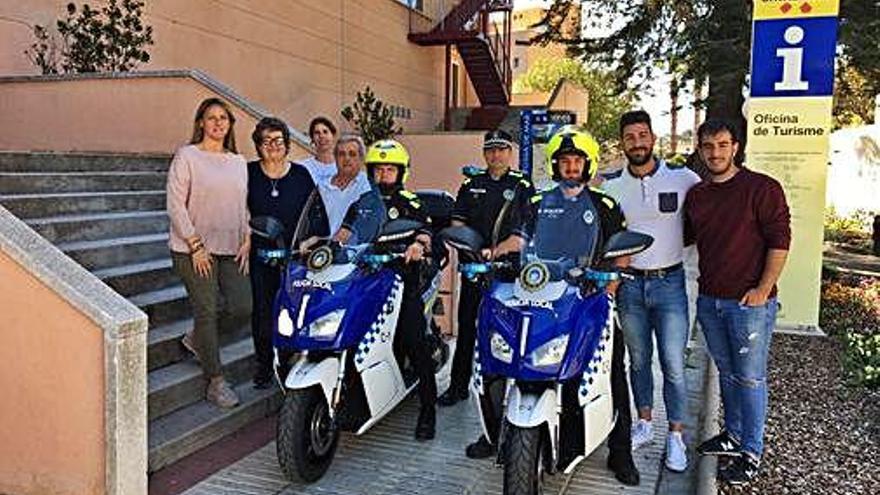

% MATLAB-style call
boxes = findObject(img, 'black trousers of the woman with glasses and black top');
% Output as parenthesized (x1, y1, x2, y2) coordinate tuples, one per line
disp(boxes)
(250, 254, 281, 380)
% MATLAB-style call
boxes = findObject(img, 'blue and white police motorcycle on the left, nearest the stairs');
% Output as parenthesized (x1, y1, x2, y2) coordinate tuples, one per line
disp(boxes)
(251, 194, 449, 482)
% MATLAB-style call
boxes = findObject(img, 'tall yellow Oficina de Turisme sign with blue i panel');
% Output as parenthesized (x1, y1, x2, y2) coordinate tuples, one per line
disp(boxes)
(746, 0, 839, 328)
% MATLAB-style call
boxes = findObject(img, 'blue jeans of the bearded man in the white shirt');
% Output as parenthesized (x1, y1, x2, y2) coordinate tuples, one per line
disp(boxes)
(617, 270, 689, 423)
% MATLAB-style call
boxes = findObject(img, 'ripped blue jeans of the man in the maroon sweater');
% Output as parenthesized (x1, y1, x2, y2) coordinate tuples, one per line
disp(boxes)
(697, 294, 777, 459)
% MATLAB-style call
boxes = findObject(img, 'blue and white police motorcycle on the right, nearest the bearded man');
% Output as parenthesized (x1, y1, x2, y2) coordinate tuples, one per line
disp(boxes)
(441, 225, 653, 495)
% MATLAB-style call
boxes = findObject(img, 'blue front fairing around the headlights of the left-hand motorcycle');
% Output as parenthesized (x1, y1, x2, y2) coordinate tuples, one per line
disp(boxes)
(272, 263, 396, 351)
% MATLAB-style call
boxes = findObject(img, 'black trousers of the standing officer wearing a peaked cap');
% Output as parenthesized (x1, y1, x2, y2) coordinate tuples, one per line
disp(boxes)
(449, 277, 483, 393)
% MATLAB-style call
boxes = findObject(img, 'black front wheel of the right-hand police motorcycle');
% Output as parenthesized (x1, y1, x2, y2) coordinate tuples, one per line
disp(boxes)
(503, 424, 544, 495)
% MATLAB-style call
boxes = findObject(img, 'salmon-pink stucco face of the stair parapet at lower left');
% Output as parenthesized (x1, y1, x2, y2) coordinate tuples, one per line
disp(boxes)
(0, 253, 105, 495)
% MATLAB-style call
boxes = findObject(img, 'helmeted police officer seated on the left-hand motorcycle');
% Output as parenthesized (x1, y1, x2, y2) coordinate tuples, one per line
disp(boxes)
(364, 139, 438, 440)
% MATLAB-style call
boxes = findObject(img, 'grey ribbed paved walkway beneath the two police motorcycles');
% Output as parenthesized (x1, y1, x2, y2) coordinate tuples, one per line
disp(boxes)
(184, 252, 707, 495)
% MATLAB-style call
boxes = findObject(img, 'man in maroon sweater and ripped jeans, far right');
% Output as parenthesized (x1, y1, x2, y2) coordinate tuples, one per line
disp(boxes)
(685, 120, 791, 485)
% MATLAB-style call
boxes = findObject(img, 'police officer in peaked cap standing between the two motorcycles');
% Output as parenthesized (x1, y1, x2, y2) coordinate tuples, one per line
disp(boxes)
(438, 130, 535, 457)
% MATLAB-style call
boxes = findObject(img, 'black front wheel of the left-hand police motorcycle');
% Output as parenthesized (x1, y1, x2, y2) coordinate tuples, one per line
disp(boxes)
(275, 386, 339, 483)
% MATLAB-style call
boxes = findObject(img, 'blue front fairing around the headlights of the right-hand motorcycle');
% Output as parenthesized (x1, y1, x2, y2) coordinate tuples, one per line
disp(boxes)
(477, 282, 611, 381)
